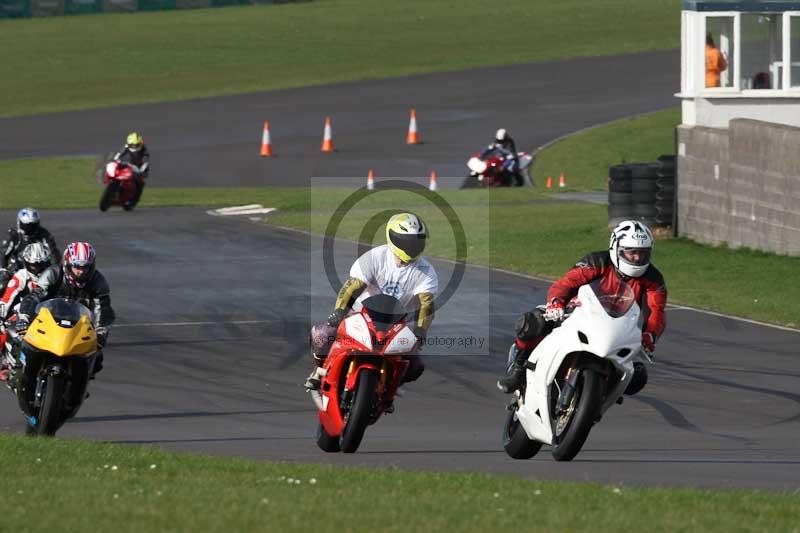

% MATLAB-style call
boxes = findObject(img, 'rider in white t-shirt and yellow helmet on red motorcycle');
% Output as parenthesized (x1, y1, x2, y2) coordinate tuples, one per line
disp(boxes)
(305, 213, 439, 390)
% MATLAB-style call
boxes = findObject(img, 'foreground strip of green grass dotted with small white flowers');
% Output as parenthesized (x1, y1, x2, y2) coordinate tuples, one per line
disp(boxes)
(0, 436, 800, 533)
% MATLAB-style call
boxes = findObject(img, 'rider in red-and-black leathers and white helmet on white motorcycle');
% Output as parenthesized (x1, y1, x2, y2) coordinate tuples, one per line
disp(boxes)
(497, 220, 667, 395)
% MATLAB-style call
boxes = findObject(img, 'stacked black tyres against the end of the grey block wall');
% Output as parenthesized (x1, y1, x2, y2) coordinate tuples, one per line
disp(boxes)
(608, 155, 675, 226)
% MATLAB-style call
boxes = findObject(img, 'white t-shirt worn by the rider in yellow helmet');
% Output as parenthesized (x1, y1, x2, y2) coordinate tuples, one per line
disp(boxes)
(350, 244, 439, 311)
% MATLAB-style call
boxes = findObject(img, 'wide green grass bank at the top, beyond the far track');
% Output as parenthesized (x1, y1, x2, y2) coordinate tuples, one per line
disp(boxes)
(0, 0, 680, 116)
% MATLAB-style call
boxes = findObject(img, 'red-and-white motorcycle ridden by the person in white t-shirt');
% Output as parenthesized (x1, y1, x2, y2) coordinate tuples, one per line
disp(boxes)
(311, 294, 419, 453)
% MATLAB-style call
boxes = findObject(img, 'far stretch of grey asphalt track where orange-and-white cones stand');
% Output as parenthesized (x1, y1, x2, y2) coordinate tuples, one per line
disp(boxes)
(0, 51, 680, 187)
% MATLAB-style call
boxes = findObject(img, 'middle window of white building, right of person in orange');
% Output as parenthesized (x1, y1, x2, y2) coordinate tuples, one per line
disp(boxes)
(741, 13, 783, 89)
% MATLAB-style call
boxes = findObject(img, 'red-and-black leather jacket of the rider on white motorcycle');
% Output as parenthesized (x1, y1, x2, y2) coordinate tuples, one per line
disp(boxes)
(547, 251, 667, 341)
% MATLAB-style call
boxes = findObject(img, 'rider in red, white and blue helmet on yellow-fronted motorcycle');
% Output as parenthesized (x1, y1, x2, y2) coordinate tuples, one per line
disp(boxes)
(17, 242, 116, 376)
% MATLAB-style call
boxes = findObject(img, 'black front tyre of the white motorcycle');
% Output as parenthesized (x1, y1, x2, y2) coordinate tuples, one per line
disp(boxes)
(552, 368, 603, 461)
